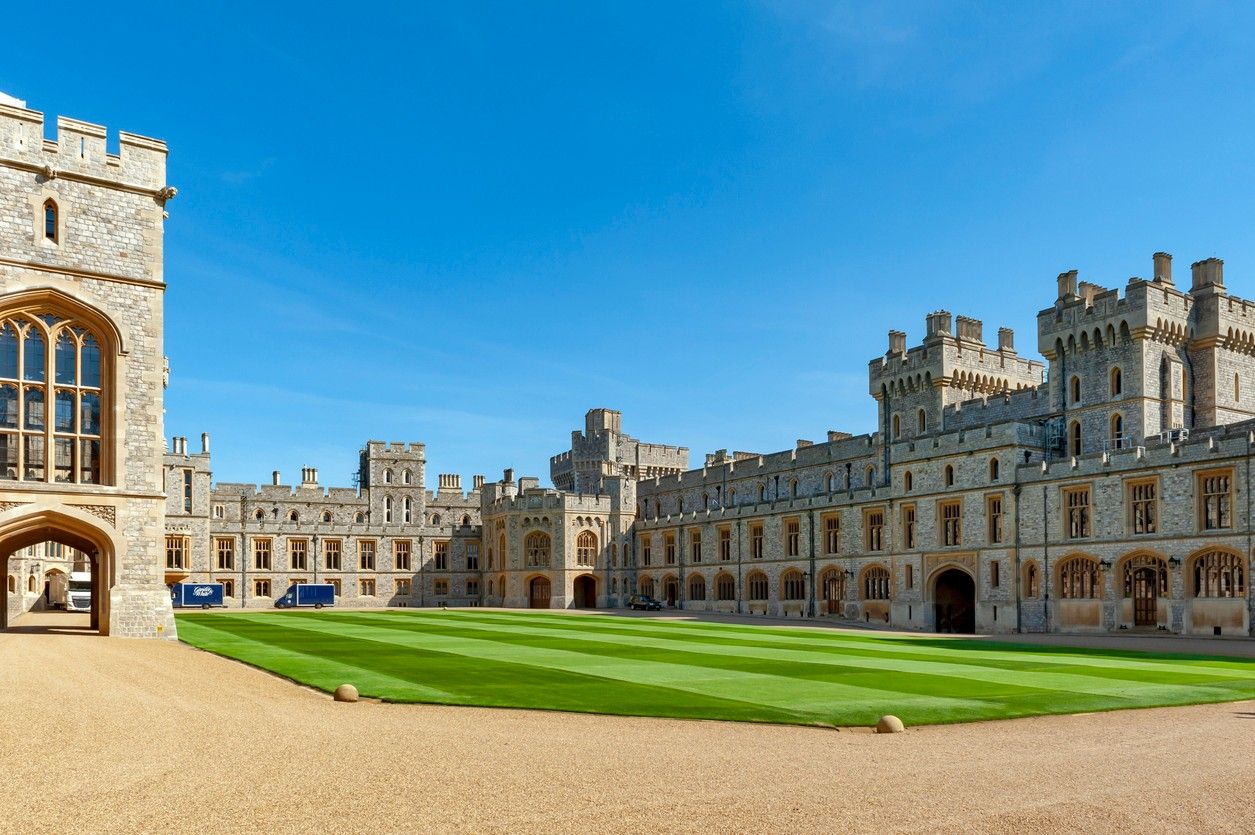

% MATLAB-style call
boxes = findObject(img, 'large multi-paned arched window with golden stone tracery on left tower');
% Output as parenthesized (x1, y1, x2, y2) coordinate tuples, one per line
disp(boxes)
(0, 309, 108, 485)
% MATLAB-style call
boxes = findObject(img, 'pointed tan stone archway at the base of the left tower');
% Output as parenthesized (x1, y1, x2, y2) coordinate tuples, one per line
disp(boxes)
(0, 510, 115, 635)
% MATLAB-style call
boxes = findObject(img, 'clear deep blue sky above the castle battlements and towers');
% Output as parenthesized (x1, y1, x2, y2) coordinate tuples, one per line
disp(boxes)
(0, 3, 1255, 485)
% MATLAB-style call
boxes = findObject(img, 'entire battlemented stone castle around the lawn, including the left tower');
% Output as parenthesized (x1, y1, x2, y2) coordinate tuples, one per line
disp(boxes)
(0, 92, 1255, 637)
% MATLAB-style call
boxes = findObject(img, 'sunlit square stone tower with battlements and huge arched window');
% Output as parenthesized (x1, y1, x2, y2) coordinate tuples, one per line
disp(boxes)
(0, 97, 174, 638)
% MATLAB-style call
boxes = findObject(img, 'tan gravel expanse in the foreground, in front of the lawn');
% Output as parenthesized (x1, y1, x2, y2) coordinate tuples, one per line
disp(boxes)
(7, 613, 1255, 834)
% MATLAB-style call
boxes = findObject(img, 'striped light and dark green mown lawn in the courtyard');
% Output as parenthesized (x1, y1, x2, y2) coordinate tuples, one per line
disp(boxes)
(178, 609, 1255, 726)
